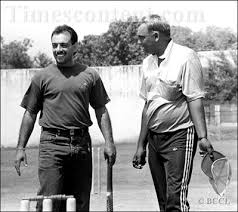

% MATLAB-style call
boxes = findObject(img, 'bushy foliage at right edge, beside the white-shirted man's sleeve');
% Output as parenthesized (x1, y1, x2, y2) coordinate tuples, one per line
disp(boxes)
(205, 53, 237, 103)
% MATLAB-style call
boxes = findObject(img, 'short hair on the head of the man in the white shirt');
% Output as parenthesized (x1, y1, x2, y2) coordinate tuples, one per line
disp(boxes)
(147, 14, 170, 37)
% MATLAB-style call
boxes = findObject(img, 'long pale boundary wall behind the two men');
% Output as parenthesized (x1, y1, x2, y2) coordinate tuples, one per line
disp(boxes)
(1, 65, 237, 146)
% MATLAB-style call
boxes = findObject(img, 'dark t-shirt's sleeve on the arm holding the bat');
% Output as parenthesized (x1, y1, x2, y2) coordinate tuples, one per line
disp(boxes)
(89, 77, 110, 109)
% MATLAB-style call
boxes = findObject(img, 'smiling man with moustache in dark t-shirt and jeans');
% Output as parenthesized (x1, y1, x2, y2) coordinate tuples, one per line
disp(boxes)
(15, 25, 116, 211)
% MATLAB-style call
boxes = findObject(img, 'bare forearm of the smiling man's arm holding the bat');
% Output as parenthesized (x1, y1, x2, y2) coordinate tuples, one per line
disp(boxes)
(95, 107, 114, 143)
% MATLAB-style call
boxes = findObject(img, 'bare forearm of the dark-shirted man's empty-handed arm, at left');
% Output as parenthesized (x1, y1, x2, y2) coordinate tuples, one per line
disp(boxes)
(17, 111, 36, 148)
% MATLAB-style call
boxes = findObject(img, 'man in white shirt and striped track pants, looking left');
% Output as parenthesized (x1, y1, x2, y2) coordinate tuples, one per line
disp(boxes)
(133, 15, 213, 211)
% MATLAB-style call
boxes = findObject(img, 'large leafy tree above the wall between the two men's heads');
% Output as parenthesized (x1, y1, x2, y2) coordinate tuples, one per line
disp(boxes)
(76, 17, 144, 66)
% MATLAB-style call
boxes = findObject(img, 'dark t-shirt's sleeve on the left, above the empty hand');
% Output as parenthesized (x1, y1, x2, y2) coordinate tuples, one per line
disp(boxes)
(20, 76, 42, 114)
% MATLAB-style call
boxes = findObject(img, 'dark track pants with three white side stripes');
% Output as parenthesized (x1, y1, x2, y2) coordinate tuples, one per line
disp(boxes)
(148, 127, 197, 211)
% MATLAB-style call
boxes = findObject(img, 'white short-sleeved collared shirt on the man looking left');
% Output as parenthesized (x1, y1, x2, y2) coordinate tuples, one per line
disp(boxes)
(140, 40, 205, 133)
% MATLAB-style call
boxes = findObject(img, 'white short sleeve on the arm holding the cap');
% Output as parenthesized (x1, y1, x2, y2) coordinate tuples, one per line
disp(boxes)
(182, 52, 206, 102)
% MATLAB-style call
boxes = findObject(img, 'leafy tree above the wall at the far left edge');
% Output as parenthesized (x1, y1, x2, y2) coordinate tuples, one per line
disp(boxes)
(1, 37, 33, 68)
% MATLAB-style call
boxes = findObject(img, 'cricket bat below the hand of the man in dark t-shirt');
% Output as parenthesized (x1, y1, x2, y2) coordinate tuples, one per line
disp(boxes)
(107, 162, 113, 212)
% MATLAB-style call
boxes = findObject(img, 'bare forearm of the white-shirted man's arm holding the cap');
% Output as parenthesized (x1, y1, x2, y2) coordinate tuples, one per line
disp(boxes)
(188, 98, 207, 138)
